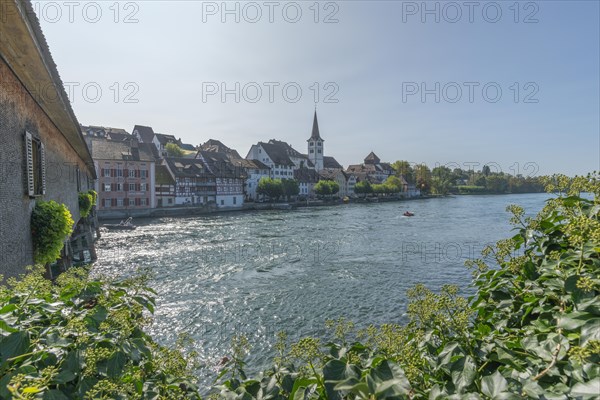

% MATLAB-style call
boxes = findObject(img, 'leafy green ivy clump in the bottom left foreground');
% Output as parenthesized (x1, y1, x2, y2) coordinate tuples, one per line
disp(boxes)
(0, 267, 200, 399)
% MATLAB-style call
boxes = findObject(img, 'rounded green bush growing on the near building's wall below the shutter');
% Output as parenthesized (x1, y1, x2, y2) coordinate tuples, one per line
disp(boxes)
(31, 200, 73, 264)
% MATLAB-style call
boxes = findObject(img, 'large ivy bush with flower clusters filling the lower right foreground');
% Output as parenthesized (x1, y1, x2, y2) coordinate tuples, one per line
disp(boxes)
(217, 174, 600, 399)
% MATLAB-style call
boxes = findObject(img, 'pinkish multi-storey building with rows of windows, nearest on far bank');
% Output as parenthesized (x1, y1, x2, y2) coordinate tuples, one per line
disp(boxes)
(87, 137, 156, 214)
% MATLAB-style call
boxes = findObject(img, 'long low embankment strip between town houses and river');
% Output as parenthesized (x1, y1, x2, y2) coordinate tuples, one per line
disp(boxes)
(98, 195, 438, 221)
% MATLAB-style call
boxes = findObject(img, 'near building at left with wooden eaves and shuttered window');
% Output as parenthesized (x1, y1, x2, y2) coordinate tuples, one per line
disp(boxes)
(0, 0, 96, 278)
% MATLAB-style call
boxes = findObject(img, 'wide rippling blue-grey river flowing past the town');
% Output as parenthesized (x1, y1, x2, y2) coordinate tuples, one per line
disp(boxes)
(94, 194, 548, 379)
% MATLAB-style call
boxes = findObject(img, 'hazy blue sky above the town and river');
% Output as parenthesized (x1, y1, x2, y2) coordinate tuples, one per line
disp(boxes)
(33, 0, 600, 176)
